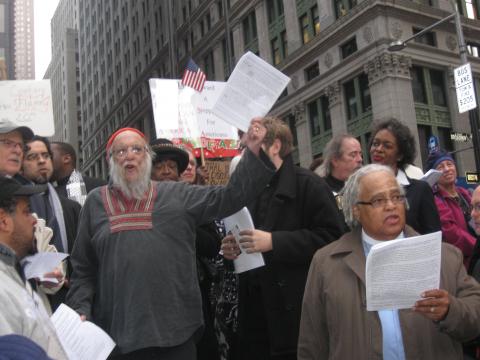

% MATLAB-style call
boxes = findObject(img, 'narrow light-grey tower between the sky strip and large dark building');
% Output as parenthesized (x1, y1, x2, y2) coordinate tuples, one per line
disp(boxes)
(44, 0, 83, 167)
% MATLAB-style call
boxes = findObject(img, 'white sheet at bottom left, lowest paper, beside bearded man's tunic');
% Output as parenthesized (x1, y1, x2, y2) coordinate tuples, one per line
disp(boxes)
(51, 304, 115, 360)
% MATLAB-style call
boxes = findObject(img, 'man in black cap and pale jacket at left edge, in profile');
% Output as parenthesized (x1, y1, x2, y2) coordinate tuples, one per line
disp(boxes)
(0, 176, 67, 359)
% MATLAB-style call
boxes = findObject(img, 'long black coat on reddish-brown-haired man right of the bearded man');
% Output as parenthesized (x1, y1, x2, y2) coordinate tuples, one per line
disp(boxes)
(239, 156, 343, 355)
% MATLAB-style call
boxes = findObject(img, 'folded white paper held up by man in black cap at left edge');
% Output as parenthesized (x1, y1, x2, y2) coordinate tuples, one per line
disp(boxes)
(22, 252, 68, 283)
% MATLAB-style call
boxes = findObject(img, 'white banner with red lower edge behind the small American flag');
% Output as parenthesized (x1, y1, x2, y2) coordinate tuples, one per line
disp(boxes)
(149, 79, 238, 158)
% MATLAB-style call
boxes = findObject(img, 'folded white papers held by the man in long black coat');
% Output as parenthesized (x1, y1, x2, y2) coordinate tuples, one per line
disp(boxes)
(223, 207, 265, 274)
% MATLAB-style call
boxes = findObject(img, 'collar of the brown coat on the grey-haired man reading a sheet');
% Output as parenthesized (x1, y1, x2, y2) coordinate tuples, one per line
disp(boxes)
(330, 225, 418, 285)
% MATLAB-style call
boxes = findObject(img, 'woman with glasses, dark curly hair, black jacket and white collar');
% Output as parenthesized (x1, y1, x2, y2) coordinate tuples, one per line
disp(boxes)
(369, 119, 441, 234)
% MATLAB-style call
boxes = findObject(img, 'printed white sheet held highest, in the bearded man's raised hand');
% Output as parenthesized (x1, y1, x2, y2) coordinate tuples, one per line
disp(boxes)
(213, 51, 290, 131)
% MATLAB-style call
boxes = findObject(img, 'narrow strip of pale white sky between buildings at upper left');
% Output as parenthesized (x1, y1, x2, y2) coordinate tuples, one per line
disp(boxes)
(34, 0, 59, 80)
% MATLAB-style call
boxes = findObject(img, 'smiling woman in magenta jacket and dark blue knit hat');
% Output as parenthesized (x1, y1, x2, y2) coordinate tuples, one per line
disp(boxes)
(427, 150, 477, 269)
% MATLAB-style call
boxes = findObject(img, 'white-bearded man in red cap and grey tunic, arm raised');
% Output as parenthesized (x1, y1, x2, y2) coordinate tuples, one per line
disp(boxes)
(67, 119, 274, 360)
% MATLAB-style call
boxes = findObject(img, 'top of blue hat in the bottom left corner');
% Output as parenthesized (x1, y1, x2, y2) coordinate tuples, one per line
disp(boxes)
(0, 334, 50, 360)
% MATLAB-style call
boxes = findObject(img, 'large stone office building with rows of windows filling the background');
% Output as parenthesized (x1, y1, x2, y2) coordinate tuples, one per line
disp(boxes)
(74, 0, 480, 176)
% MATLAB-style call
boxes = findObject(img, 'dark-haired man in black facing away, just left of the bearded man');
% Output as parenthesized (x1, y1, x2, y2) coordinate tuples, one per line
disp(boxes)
(50, 141, 107, 205)
